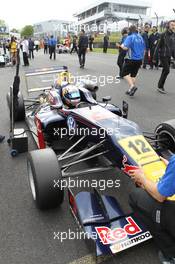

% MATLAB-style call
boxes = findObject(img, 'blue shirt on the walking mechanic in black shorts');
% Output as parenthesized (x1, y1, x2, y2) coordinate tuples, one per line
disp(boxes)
(123, 33, 145, 60)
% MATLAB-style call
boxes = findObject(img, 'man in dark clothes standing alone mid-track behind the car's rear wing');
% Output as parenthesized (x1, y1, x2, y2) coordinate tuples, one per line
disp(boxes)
(78, 29, 88, 69)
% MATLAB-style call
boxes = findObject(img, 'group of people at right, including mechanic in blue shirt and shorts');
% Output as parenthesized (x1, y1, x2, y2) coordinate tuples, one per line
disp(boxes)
(116, 21, 175, 96)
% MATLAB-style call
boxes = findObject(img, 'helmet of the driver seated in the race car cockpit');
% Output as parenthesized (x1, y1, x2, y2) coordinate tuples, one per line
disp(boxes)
(62, 85, 81, 107)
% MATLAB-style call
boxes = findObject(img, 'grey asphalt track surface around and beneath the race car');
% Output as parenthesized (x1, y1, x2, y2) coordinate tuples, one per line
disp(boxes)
(0, 51, 175, 264)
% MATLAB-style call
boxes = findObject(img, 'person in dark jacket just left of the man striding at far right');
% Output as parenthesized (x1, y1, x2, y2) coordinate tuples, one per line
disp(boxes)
(149, 26, 160, 69)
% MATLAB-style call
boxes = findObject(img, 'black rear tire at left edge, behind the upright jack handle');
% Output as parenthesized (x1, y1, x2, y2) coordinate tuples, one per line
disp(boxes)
(7, 92, 25, 121)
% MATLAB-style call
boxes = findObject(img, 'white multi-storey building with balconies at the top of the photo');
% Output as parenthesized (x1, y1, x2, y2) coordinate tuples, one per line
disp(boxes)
(74, 0, 151, 32)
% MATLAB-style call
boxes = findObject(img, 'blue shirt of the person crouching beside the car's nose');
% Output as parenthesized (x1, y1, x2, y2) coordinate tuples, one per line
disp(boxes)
(157, 155, 175, 197)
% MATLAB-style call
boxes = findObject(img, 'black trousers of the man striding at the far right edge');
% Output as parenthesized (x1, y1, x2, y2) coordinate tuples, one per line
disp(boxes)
(158, 57, 171, 88)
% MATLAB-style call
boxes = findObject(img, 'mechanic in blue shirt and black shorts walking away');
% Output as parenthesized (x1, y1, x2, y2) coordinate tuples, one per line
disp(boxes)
(120, 25, 145, 96)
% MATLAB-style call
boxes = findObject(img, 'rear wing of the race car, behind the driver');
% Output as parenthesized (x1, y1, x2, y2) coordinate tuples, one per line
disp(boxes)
(25, 66, 68, 93)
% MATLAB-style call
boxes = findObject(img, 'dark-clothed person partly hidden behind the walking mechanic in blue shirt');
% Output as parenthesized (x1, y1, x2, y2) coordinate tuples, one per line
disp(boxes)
(116, 28, 128, 79)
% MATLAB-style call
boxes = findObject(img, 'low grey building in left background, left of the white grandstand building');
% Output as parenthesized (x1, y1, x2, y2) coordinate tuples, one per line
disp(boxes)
(33, 20, 73, 38)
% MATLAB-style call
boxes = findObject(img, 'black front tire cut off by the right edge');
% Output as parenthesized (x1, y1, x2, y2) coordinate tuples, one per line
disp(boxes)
(155, 119, 175, 153)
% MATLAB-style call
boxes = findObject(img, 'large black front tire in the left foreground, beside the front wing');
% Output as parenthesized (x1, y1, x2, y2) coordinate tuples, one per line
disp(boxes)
(27, 148, 64, 210)
